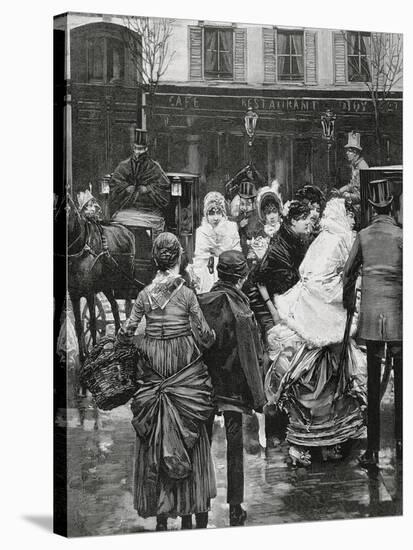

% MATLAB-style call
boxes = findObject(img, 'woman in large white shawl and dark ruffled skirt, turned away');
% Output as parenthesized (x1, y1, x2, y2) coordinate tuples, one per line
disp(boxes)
(266, 198, 366, 465)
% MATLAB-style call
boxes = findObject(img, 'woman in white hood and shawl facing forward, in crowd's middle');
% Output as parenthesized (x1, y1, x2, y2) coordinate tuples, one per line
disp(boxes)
(192, 191, 241, 294)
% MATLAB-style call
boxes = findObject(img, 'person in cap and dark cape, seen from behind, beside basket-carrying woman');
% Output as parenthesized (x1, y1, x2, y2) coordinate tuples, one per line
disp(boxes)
(198, 250, 265, 526)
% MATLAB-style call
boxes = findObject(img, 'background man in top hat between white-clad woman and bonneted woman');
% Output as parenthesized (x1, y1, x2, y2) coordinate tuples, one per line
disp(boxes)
(237, 179, 262, 263)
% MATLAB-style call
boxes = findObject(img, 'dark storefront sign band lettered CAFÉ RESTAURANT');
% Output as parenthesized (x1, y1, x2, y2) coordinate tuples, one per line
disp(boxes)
(156, 94, 401, 114)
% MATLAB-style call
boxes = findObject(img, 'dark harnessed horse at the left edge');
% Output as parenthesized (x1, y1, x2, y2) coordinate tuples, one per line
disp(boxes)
(66, 195, 136, 364)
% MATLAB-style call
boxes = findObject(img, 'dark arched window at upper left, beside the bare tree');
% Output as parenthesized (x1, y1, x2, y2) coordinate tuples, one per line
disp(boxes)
(87, 36, 125, 84)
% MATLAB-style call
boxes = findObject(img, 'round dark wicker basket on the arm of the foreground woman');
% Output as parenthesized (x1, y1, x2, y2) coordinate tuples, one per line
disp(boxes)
(80, 337, 149, 410)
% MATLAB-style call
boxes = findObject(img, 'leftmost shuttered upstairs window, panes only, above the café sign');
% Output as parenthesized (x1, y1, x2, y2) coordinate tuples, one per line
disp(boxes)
(204, 28, 234, 80)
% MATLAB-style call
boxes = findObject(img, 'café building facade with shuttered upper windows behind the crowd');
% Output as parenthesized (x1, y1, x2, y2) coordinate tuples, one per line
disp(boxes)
(54, 14, 402, 202)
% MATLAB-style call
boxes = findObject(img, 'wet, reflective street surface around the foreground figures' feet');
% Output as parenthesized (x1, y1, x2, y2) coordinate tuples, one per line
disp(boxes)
(60, 384, 402, 536)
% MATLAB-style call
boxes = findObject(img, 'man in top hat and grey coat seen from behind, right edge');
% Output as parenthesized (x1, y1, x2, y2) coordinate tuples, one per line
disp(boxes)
(343, 180, 403, 468)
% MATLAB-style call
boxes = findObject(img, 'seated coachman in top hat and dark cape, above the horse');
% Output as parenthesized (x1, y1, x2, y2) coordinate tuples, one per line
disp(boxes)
(109, 128, 171, 219)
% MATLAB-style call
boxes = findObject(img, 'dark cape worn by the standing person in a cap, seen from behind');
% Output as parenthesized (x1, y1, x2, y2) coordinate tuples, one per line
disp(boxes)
(198, 281, 265, 411)
